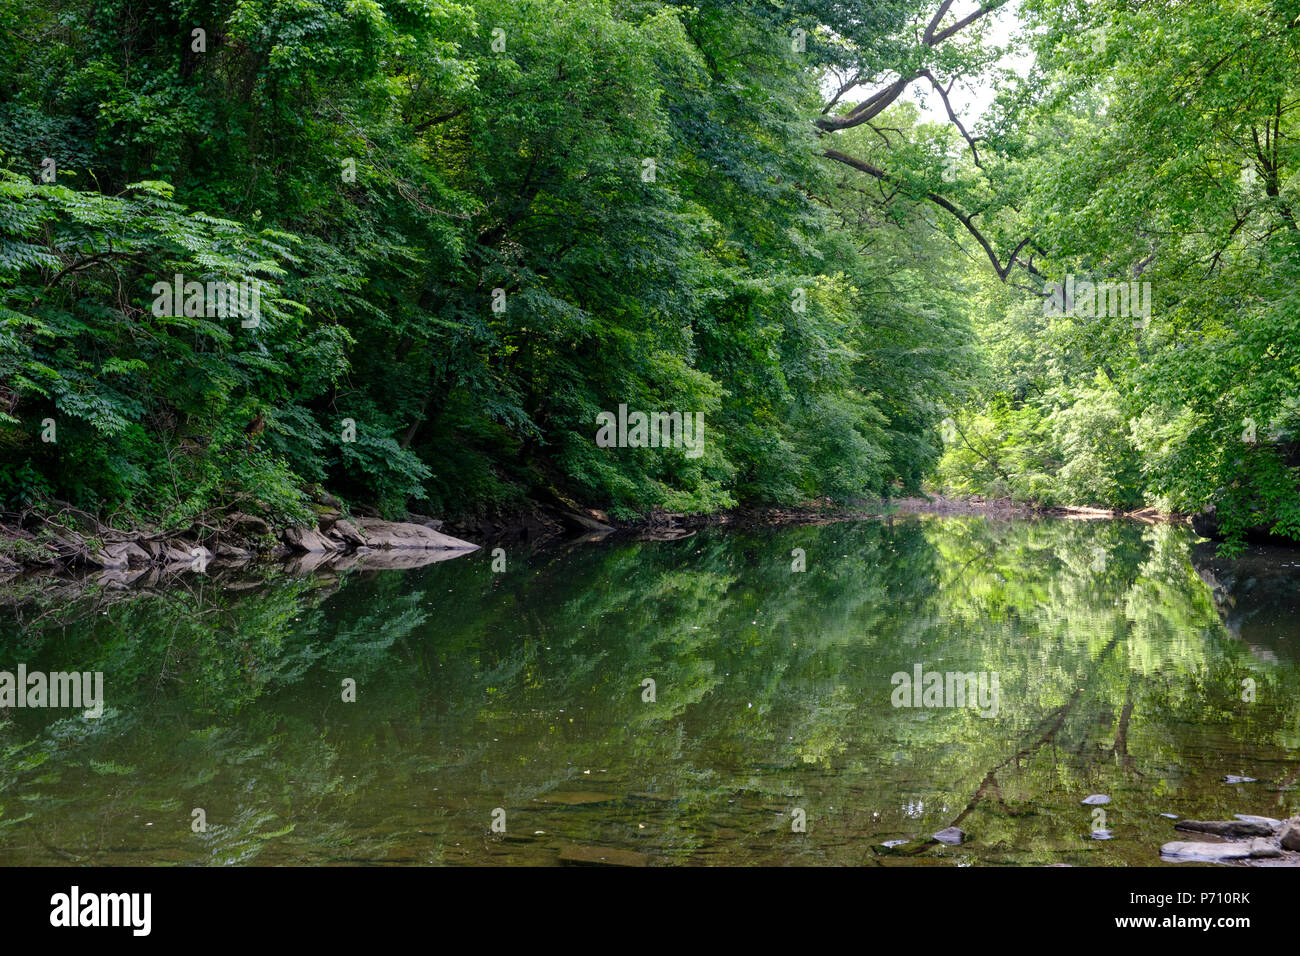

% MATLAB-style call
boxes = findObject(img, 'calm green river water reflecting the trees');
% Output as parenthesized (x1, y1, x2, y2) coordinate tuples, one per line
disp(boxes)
(0, 516, 1300, 866)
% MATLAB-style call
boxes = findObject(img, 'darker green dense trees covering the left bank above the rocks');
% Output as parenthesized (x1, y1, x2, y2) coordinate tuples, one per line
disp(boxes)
(0, 0, 969, 525)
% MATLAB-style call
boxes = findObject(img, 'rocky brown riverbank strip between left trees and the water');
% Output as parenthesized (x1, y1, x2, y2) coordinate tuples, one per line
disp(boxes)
(0, 492, 1186, 576)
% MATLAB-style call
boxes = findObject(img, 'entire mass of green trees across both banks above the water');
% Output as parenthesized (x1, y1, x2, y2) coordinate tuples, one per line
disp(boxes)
(0, 0, 1300, 540)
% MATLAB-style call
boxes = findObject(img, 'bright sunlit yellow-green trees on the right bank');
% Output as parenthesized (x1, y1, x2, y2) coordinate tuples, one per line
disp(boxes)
(940, 0, 1300, 541)
